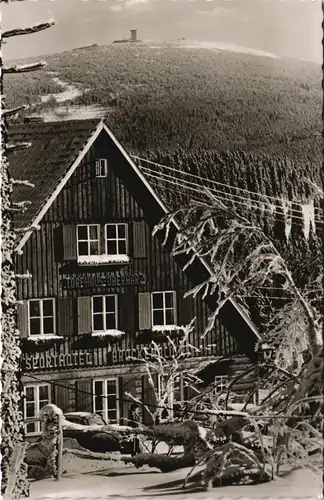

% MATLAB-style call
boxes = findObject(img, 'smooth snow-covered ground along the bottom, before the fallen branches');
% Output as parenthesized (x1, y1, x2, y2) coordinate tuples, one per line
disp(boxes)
(30, 455, 322, 499)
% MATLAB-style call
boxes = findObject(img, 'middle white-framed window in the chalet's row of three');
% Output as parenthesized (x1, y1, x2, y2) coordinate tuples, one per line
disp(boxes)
(92, 295, 117, 332)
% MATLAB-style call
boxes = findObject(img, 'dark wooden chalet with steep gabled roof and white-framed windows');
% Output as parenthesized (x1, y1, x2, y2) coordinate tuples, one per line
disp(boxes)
(10, 120, 258, 436)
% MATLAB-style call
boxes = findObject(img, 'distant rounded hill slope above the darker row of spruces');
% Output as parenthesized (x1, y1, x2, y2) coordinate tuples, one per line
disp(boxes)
(5, 40, 322, 162)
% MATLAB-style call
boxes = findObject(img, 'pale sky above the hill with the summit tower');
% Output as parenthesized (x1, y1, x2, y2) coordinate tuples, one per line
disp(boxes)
(1, 0, 322, 63)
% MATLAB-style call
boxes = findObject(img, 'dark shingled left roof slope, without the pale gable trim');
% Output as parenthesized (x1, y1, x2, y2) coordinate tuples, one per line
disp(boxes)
(9, 119, 102, 227)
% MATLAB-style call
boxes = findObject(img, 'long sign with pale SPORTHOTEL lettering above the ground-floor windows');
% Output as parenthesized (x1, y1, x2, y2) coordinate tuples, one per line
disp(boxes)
(22, 345, 193, 372)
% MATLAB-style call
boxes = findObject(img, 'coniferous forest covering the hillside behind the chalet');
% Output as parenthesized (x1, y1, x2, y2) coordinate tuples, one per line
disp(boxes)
(7, 42, 324, 332)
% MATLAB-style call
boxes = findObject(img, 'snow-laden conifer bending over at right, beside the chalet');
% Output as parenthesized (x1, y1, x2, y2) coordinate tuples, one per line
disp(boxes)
(151, 191, 323, 487)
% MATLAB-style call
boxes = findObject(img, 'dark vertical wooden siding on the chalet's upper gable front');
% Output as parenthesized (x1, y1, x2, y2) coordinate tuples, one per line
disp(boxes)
(17, 129, 243, 364)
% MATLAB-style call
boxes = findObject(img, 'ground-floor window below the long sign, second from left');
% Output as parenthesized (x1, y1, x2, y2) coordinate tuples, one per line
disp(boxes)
(93, 378, 119, 423)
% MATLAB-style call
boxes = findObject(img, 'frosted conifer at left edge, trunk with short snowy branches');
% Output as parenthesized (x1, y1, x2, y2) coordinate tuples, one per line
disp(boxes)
(0, 6, 54, 498)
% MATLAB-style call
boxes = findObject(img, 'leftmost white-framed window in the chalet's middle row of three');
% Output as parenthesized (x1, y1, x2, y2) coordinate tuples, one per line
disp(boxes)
(28, 299, 55, 336)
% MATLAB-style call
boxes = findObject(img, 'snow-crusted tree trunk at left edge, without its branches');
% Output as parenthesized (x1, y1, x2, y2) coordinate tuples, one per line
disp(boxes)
(0, 117, 29, 498)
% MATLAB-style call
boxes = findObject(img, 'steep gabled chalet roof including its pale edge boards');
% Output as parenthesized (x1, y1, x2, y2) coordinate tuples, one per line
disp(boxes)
(9, 120, 260, 338)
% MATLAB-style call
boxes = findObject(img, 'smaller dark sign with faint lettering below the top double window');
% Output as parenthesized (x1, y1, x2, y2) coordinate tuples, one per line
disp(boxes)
(61, 272, 146, 290)
